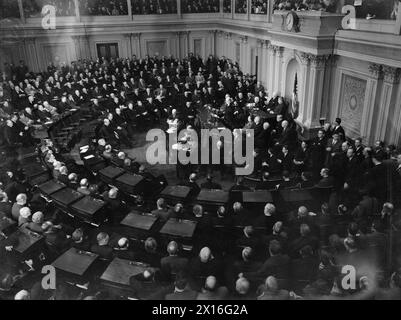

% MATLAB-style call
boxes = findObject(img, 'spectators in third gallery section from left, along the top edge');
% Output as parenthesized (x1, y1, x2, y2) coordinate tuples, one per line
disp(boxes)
(79, 0, 128, 16)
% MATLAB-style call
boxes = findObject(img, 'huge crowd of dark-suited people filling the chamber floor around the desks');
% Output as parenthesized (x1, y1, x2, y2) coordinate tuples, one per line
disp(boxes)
(0, 54, 401, 300)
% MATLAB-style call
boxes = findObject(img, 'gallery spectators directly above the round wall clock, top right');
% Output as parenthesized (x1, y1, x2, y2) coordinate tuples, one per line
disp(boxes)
(273, 0, 341, 13)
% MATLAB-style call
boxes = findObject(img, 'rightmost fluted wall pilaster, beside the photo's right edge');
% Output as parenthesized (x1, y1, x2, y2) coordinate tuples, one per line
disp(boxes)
(376, 66, 400, 143)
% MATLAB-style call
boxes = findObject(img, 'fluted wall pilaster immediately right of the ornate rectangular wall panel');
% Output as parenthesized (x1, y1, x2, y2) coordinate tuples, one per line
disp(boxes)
(361, 63, 383, 144)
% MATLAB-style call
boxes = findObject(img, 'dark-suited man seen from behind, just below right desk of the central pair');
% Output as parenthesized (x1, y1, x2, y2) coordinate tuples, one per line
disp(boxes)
(160, 241, 189, 280)
